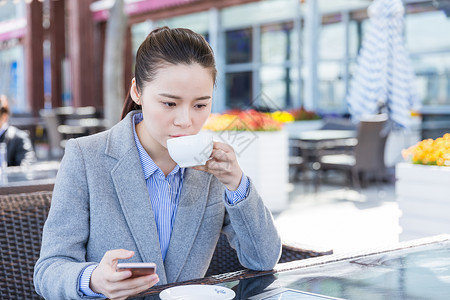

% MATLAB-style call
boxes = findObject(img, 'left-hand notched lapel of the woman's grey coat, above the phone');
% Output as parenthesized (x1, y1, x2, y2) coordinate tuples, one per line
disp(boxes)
(106, 114, 167, 284)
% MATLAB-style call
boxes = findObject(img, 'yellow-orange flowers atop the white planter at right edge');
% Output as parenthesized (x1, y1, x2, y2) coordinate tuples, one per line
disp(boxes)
(402, 133, 450, 166)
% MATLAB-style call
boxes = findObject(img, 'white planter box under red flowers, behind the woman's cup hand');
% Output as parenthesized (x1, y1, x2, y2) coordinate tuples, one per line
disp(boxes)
(214, 130, 289, 212)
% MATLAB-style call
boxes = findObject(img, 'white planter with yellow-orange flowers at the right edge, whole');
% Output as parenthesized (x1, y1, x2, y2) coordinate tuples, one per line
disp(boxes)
(395, 133, 450, 240)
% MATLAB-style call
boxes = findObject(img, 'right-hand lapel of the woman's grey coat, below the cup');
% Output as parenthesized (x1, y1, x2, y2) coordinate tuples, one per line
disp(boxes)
(165, 169, 211, 282)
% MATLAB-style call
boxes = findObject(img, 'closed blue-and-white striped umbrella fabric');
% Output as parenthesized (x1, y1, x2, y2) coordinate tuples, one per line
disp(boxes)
(347, 0, 420, 128)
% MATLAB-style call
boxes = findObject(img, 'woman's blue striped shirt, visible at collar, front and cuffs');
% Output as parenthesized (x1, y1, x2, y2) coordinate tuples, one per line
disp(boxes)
(80, 113, 250, 298)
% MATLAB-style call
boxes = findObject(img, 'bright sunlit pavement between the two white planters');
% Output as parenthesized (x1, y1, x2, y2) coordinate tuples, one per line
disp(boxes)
(274, 173, 401, 253)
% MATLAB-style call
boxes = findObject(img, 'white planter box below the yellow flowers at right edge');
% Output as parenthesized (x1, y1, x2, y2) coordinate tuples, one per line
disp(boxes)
(395, 163, 450, 241)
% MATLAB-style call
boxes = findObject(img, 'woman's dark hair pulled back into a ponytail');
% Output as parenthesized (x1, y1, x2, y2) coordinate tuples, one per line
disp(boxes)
(122, 26, 217, 119)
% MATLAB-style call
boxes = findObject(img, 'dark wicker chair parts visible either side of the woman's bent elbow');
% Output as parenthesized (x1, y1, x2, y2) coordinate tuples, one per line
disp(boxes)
(205, 234, 333, 277)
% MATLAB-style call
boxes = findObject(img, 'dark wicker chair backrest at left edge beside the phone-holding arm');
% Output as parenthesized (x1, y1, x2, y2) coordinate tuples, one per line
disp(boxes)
(0, 192, 52, 299)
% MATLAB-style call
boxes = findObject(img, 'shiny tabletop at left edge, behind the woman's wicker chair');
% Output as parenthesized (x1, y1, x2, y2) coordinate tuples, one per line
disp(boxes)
(0, 161, 60, 195)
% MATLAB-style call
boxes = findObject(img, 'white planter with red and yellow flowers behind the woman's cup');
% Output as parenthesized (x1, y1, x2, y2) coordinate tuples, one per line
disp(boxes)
(203, 110, 288, 212)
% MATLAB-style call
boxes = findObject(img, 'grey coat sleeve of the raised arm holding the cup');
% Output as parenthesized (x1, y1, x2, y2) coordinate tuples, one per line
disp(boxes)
(223, 180, 281, 271)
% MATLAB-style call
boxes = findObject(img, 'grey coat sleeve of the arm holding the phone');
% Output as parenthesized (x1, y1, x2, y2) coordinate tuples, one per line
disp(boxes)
(34, 140, 96, 299)
